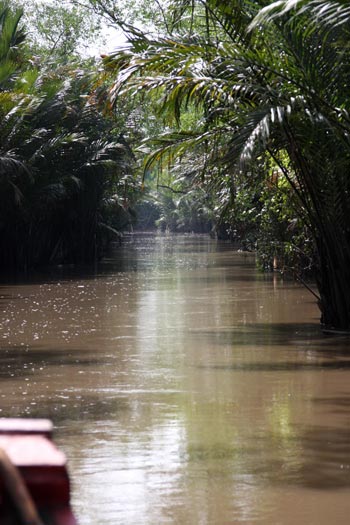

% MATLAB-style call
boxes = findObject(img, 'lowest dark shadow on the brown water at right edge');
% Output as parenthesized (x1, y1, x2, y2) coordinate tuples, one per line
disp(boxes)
(188, 426, 350, 491)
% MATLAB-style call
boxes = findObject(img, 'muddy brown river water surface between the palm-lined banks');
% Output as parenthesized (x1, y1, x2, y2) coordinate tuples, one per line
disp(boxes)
(0, 236, 350, 525)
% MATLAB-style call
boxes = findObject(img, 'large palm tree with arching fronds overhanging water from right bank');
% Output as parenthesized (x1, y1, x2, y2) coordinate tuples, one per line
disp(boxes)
(106, 0, 350, 330)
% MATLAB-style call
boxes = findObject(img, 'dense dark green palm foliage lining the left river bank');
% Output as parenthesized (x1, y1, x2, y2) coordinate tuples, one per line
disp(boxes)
(0, 2, 136, 270)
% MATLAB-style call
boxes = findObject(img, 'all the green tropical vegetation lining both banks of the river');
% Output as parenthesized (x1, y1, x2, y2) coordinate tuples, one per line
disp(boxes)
(0, 0, 350, 330)
